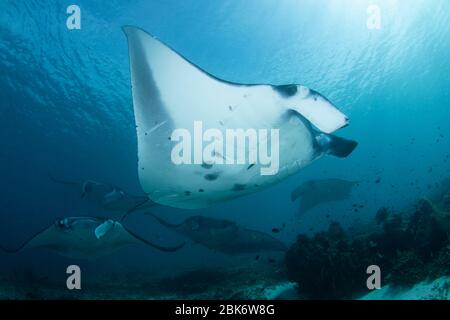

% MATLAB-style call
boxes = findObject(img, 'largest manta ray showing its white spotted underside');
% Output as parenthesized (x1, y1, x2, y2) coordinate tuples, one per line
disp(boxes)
(123, 26, 357, 209)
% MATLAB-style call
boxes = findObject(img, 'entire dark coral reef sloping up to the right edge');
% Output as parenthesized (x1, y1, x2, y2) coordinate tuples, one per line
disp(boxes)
(285, 184, 450, 299)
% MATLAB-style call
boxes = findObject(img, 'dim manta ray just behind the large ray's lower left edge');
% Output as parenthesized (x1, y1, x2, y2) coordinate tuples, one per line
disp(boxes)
(50, 176, 157, 219)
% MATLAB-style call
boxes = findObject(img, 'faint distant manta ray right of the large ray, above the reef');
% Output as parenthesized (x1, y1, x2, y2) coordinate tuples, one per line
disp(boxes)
(291, 179, 359, 214)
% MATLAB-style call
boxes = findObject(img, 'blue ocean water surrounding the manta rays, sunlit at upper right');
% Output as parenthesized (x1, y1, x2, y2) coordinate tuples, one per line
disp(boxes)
(0, 0, 450, 296)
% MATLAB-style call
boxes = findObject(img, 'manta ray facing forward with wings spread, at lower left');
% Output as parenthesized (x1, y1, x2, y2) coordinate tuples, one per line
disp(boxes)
(0, 217, 184, 259)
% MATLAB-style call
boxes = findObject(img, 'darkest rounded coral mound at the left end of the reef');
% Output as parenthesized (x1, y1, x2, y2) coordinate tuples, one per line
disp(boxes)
(286, 222, 373, 299)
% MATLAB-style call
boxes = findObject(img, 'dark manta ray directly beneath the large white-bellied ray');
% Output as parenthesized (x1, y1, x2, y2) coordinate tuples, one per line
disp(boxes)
(147, 213, 287, 254)
